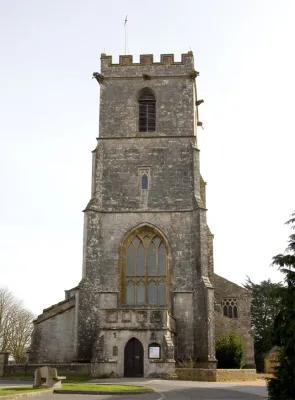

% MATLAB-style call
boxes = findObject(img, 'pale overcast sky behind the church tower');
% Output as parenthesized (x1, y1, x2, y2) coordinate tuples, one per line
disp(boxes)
(0, 0, 295, 314)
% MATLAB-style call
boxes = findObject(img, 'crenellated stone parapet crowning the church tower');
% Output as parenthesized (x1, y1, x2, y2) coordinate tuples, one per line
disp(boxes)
(101, 51, 194, 77)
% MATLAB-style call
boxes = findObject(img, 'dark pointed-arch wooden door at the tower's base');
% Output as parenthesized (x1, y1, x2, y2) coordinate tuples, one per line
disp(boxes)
(124, 338, 143, 378)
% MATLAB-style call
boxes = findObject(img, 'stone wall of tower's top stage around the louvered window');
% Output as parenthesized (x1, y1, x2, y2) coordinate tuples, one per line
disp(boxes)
(99, 54, 195, 138)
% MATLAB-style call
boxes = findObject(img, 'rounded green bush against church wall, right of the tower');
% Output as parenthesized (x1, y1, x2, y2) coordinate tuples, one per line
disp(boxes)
(216, 332, 244, 369)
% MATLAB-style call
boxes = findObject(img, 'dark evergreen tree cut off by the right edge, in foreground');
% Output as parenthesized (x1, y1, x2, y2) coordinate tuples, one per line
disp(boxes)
(268, 213, 295, 400)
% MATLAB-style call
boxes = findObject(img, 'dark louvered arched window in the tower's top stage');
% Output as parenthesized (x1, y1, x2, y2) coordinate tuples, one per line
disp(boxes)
(138, 89, 156, 132)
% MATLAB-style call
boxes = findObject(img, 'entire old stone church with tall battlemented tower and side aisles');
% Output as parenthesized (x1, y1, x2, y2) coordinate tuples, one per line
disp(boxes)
(29, 51, 254, 377)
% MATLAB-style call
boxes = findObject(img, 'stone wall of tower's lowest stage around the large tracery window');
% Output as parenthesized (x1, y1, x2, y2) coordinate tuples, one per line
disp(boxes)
(79, 210, 214, 361)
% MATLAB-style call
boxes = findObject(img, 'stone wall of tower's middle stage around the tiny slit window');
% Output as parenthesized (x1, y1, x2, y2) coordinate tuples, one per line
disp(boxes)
(91, 136, 198, 212)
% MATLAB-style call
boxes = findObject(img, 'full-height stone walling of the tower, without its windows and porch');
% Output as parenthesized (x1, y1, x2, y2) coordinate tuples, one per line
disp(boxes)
(78, 53, 215, 361)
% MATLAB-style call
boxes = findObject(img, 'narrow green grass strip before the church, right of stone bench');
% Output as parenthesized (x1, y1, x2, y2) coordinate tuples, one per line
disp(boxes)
(58, 383, 151, 392)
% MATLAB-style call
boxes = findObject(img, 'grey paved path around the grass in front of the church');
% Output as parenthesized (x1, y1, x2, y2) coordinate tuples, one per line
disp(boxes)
(0, 379, 267, 400)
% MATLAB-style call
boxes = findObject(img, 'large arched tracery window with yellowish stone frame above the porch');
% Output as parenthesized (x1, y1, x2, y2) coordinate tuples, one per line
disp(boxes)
(122, 229, 168, 306)
